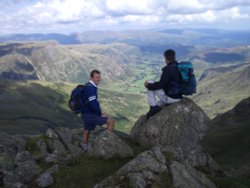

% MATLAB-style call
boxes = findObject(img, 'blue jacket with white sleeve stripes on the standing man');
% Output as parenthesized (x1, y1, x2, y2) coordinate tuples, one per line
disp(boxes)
(82, 81, 102, 116)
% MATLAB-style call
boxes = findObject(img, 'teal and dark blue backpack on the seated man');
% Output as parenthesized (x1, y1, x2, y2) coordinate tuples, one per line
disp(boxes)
(173, 61, 197, 95)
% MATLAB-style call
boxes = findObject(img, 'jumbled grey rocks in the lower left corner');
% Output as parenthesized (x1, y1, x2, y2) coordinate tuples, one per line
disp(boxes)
(0, 128, 82, 187)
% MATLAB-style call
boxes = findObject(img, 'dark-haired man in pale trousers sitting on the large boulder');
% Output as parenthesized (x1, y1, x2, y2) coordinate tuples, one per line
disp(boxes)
(144, 49, 182, 118)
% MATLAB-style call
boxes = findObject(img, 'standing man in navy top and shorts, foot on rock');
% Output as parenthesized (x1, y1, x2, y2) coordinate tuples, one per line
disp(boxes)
(81, 70, 115, 152)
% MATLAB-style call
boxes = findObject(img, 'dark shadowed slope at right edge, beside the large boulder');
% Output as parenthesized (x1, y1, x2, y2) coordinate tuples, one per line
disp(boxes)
(203, 97, 250, 173)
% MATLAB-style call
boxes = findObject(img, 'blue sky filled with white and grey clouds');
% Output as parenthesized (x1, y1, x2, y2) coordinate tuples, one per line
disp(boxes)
(0, 0, 250, 35)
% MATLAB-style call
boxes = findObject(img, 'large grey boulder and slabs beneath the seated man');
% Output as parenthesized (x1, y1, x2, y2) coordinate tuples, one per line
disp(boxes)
(95, 98, 220, 188)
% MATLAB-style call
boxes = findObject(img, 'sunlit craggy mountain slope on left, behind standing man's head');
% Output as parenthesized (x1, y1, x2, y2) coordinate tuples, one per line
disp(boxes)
(0, 41, 139, 82)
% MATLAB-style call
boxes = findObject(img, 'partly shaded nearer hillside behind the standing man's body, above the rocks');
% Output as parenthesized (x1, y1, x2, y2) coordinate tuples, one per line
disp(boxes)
(0, 80, 146, 134)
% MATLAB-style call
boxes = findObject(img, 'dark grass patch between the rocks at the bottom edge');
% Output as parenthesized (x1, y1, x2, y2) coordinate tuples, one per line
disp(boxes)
(51, 155, 131, 188)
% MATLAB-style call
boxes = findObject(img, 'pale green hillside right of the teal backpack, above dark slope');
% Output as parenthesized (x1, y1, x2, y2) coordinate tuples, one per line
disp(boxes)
(193, 64, 250, 117)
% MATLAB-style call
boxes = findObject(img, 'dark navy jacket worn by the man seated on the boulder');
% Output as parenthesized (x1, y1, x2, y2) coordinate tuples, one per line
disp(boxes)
(148, 61, 182, 99)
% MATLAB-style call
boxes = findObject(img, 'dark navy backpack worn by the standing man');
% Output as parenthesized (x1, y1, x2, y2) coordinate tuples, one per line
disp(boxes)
(68, 85, 86, 114)
